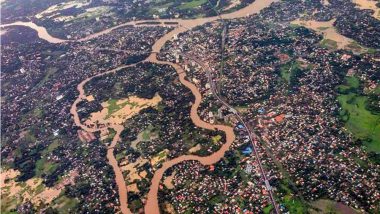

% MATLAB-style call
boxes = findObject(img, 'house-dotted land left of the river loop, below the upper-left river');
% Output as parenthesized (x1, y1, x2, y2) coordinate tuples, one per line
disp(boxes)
(1, 26, 167, 211)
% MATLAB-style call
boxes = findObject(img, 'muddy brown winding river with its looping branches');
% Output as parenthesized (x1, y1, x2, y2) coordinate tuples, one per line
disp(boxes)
(0, 0, 279, 214)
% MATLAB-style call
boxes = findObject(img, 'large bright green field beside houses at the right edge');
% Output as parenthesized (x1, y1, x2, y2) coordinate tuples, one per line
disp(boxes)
(337, 77, 380, 152)
